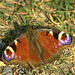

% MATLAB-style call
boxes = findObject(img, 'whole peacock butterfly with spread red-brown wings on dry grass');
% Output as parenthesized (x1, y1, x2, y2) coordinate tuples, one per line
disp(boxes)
(2, 28, 74, 67)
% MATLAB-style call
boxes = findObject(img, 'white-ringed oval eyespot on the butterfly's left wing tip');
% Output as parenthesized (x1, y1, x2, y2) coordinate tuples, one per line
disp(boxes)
(3, 47, 14, 62)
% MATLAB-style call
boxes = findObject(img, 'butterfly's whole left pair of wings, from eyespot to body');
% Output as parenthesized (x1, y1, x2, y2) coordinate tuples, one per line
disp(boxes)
(2, 29, 41, 66)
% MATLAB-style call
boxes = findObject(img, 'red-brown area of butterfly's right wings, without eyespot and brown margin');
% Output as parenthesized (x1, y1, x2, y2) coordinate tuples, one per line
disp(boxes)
(37, 31, 60, 61)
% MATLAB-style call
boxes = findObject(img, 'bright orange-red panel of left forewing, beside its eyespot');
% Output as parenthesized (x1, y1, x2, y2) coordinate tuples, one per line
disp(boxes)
(15, 37, 29, 62)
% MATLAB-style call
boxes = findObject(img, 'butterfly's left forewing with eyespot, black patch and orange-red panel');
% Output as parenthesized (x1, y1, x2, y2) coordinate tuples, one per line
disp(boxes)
(2, 34, 29, 65)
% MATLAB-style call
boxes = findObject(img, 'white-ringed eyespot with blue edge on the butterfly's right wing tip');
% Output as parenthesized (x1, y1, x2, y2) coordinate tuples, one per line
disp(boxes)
(58, 32, 71, 45)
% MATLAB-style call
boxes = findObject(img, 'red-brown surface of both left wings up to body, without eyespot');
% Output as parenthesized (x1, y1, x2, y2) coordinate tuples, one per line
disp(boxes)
(16, 32, 41, 66)
